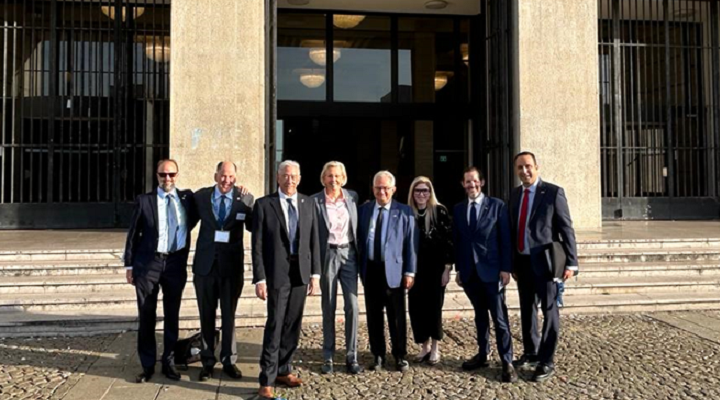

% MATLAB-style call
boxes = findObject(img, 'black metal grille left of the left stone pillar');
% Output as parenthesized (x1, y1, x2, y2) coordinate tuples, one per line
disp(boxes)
(0, 0, 170, 227)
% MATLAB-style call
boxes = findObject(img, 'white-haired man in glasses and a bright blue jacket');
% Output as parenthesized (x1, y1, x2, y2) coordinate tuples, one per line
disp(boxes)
(358, 171, 420, 372)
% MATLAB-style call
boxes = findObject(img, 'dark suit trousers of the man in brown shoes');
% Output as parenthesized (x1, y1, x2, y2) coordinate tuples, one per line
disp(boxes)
(259, 260, 308, 386)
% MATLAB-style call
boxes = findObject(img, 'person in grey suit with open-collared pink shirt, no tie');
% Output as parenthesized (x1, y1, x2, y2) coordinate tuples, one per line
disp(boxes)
(313, 161, 362, 374)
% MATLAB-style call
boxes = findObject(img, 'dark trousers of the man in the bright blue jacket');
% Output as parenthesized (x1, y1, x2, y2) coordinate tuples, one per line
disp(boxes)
(365, 260, 407, 360)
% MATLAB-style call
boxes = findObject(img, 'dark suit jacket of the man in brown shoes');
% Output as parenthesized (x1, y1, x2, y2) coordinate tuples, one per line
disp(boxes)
(252, 192, 321, 289)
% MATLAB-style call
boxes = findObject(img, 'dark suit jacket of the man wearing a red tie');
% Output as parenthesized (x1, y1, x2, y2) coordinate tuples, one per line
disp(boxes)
(510, 178, 578, 276)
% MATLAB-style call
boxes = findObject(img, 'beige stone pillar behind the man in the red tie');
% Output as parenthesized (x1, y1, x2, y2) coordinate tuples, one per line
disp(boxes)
(512, 0, 602, 229)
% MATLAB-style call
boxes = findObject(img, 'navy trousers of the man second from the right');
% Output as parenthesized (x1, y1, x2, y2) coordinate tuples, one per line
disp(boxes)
(463, 271, 513, 363)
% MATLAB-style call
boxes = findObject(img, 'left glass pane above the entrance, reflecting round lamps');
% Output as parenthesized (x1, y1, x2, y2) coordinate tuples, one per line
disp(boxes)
(277, 14, 326, 101)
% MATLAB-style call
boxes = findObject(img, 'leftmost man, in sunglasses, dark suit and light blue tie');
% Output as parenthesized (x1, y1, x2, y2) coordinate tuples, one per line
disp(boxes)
(123, 160, 195, 383)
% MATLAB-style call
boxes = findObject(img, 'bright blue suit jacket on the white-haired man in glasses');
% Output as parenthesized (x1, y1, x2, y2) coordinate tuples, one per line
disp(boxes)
(357, 200, 420, 288)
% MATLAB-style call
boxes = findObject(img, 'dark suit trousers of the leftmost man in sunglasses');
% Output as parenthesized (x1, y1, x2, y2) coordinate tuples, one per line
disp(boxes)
(133, 252, 187, 368)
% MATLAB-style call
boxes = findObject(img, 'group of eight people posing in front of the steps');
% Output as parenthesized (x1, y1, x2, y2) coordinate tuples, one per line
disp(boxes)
(124, 152, 578, 398)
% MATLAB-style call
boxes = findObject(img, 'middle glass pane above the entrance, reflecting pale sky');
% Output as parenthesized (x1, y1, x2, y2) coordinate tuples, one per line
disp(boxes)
(334, 15, 392, 102)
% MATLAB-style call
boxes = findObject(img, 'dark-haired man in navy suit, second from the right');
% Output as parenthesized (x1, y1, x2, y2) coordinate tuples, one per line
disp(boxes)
(453, 167, 517, 382)
